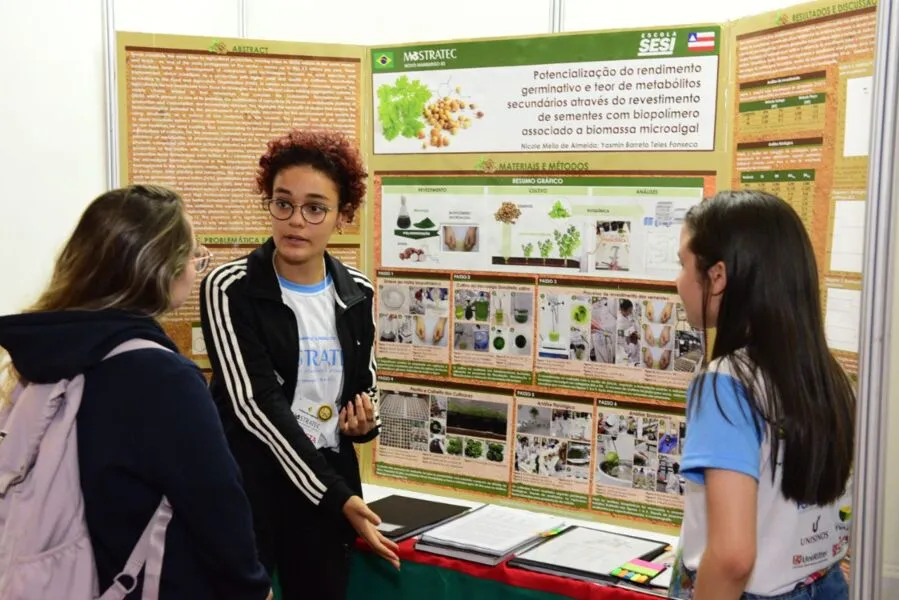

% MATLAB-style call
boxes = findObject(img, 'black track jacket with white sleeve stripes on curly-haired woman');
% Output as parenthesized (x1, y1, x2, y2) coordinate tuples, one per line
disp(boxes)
(200, 239, 380, 514)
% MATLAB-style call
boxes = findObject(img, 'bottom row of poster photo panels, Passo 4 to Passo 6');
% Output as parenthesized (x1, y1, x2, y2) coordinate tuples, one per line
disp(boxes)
(374, 384, 687, 525)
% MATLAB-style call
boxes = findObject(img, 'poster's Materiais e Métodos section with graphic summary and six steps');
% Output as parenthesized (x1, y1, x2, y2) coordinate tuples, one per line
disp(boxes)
(372, 171, 716, 525)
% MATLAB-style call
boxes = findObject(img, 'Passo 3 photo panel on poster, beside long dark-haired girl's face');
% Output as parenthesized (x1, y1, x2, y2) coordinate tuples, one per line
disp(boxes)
(535, 278, 702, 403)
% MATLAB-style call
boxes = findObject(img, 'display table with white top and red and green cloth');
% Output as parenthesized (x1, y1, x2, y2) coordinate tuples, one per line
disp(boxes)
(275, 485, 676, 600)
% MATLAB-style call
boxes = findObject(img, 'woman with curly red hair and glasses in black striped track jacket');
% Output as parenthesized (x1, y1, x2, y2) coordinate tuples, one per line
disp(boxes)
(200, 131, 399, 600)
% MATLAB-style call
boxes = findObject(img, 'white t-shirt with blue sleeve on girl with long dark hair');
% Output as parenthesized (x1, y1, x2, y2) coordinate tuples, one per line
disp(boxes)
(669, 360, 852, 598)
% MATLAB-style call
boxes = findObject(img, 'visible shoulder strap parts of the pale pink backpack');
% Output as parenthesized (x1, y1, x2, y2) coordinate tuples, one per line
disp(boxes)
(100, 338, 172, 600)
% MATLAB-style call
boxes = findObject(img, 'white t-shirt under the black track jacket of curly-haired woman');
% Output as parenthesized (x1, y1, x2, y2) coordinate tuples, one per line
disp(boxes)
(278, 275, 343, 450)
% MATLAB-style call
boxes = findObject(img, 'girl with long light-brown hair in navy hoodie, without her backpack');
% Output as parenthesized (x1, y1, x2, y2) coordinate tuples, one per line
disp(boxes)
(0, 186, 271, 600)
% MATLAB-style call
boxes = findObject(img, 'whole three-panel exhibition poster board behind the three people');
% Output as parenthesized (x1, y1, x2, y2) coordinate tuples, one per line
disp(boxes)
(119, 0, 875, 529)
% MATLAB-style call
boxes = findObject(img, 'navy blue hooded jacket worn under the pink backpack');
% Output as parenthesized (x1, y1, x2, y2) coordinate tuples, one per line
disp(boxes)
(0, 310, 271, 600)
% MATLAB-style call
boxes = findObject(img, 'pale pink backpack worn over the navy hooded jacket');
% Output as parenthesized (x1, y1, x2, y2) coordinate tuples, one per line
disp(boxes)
(0, 339, 172, 600)
